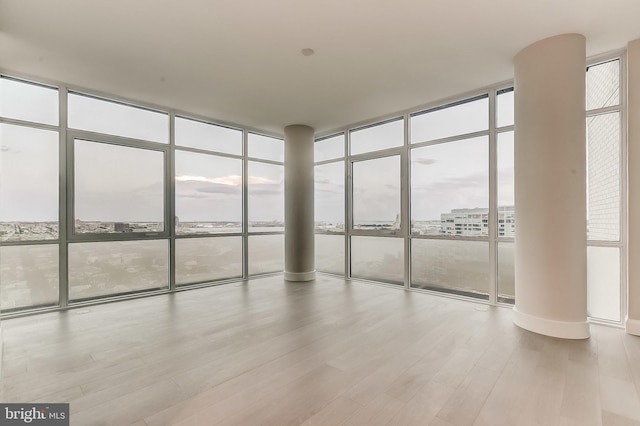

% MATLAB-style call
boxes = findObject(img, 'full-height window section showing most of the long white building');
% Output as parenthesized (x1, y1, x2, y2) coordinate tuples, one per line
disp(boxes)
(409, 94, 491, 299)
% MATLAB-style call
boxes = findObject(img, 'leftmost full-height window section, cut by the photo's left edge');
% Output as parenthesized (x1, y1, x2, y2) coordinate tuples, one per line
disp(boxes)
(0, 77, 61, 310)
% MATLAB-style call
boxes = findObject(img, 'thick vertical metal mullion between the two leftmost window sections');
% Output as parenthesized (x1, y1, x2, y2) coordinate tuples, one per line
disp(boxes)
(58, 87, 73, 308)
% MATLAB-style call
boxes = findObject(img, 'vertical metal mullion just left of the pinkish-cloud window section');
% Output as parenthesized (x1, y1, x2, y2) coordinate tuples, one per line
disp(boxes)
(165, 112, 176, 292)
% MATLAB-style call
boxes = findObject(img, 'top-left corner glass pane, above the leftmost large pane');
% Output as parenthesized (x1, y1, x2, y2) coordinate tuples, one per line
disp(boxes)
(0, 76, 58, 126)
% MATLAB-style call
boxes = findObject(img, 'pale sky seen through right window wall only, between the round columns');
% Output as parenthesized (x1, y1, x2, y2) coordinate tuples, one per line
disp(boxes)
(316, 96, 514, 224)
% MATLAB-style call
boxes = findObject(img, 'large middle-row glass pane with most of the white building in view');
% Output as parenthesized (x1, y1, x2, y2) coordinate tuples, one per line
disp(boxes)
(411, 136, 489, 237)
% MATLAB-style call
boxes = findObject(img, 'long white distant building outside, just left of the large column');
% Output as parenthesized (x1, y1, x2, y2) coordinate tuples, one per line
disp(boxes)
(440, 206, 516, 237)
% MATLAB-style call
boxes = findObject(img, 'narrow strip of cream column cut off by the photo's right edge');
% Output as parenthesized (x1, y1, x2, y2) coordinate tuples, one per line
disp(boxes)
(626, 39, 640, 336)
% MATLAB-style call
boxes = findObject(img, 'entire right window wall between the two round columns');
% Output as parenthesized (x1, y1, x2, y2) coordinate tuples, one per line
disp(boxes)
(315, 85, 515, 303)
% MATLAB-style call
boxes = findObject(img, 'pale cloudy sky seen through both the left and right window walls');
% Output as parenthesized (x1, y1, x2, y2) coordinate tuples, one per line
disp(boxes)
(0, 78, 513, 226)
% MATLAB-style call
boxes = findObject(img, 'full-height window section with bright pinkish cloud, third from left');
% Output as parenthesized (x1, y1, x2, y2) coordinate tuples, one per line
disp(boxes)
(174, 117, 243, 286)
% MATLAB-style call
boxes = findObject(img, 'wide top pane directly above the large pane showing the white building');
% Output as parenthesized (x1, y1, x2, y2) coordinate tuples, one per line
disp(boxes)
(410, 96, 489, 143)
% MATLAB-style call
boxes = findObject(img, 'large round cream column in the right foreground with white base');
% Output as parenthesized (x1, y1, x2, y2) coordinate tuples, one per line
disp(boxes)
(514, 34, 589, 339)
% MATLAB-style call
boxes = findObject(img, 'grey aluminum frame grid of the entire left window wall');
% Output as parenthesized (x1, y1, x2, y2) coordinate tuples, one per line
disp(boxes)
(0, 69, 284, 318)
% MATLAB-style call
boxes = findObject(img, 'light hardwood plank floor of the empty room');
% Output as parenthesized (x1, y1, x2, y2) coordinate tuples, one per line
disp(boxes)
(0, 276, 640, 426)
